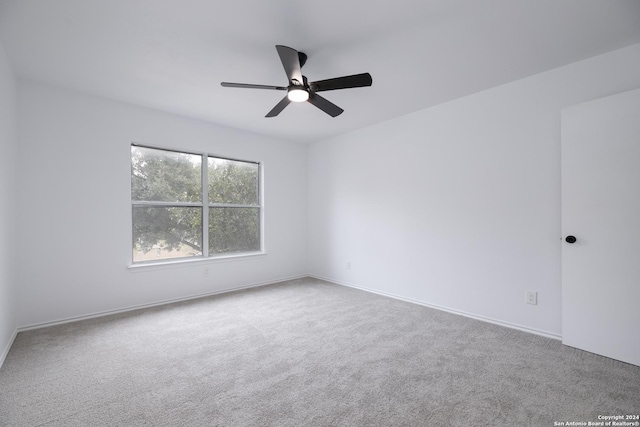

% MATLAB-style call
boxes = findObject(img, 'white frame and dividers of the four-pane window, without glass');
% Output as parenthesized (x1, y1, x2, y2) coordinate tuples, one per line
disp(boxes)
(129, 142, 266, 269)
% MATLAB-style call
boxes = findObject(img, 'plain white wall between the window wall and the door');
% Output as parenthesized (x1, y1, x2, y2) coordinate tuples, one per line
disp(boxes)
(308, 45, 640, 336)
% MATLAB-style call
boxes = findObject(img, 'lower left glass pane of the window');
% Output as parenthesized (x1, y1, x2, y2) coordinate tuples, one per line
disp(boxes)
(133, 206, 202, 262)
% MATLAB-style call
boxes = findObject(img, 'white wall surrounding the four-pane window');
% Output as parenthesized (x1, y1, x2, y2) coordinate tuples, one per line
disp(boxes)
(18, 82, 307, 327)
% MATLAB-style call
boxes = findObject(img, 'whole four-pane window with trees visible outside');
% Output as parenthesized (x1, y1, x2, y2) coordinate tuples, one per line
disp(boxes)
(131, 145, 262, 263)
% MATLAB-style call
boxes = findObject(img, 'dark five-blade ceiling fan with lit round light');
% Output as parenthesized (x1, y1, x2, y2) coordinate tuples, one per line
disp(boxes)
(220, 45, 373, 117)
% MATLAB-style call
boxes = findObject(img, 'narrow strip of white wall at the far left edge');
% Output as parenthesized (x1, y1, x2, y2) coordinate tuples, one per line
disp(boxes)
(0, 44, 18, 366)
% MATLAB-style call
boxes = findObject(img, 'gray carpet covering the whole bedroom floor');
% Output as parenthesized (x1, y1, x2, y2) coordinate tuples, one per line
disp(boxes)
(0, 279, 640, 427)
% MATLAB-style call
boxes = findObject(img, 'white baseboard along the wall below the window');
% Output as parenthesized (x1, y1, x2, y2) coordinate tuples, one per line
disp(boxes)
(18, 274, 309, 332)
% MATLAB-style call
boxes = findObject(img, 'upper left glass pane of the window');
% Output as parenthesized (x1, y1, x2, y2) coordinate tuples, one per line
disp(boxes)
(131, 146, 202, 203)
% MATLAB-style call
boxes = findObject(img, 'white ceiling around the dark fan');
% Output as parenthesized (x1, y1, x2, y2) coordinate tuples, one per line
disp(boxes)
(0, 0, 640, 142)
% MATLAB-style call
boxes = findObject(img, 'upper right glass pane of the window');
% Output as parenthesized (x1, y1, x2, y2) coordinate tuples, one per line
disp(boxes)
(209, 157, 259, 205)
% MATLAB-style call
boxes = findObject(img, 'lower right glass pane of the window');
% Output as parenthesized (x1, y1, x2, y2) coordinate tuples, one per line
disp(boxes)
(209, 208, 260, 255)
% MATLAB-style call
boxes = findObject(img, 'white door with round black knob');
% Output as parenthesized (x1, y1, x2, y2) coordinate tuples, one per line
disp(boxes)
(562, 90, 640, 366)
